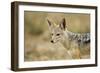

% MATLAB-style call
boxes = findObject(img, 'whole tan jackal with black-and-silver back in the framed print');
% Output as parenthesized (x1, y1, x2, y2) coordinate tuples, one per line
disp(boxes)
(47, 18, 90, 59)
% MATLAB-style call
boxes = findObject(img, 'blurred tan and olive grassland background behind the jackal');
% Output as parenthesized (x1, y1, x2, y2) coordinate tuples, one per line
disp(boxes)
(24, 11, 90, 61)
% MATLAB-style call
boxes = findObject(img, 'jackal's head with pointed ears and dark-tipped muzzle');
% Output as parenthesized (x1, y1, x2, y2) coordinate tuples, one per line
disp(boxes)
(47, 18, 66, 43)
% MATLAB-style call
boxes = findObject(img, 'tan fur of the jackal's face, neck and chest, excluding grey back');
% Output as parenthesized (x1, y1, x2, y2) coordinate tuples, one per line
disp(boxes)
(48, 20, 85, 59)
